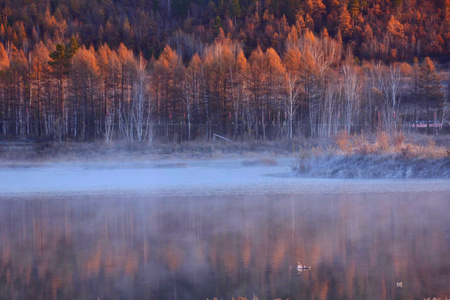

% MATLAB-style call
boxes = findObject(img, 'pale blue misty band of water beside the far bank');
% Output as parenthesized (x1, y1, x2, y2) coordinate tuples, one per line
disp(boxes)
(0, 158, 450, 198)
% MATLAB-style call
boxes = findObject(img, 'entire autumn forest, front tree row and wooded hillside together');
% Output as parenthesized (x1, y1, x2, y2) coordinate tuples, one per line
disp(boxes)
(0, 0, 450, 142)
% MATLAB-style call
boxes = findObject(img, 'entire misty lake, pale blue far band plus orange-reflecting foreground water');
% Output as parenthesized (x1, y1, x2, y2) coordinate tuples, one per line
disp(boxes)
(0, 159, 450, 299)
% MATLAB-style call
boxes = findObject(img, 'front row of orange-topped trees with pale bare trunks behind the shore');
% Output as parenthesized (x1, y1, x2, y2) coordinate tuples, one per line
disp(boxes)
(0, 30, 448, 142)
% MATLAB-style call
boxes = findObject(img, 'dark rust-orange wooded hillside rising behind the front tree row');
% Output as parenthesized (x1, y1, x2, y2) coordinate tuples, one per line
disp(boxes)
(0, 0, 450, 62)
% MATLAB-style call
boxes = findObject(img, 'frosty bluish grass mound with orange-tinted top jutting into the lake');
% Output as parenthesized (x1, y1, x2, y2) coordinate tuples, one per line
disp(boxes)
(293, 132, 450, 178)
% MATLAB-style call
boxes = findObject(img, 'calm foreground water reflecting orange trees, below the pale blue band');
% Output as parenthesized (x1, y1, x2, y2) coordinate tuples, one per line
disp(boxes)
(0, 191, 450, 299)
